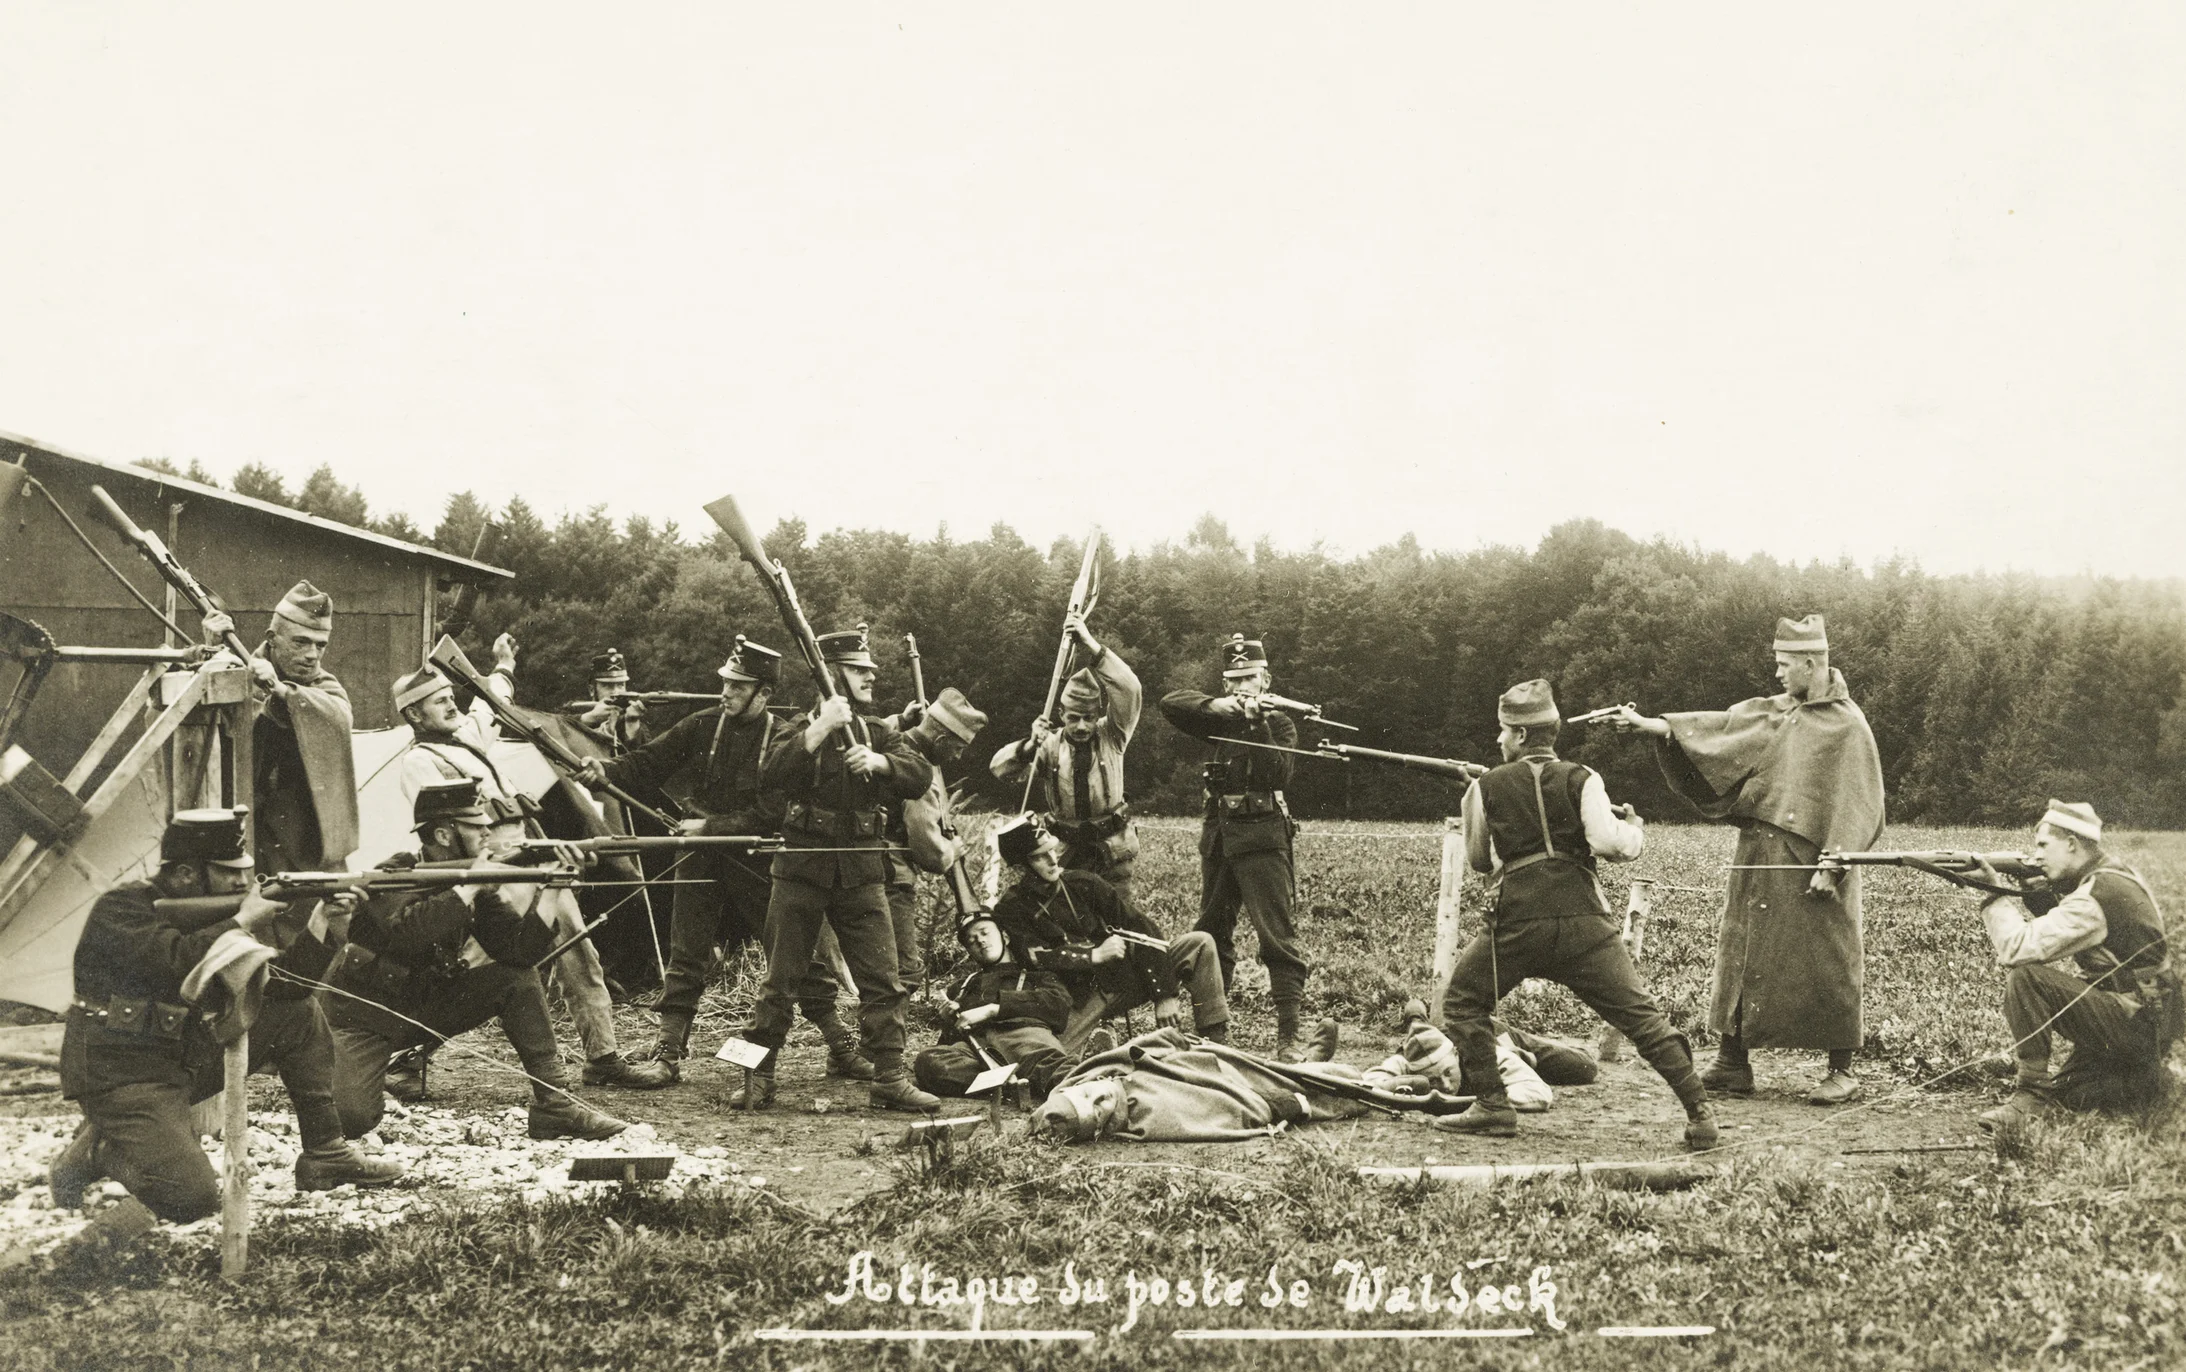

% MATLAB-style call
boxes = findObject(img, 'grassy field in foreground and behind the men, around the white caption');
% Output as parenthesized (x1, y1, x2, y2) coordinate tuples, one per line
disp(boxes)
(0, 826, 2186, 1370)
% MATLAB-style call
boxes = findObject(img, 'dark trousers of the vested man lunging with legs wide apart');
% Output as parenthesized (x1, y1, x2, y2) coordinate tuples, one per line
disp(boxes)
(1443, 913, 1707, 1105)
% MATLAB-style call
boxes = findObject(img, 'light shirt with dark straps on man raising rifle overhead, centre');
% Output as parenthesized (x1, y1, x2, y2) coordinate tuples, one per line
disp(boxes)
(988, 647, 1145, 900)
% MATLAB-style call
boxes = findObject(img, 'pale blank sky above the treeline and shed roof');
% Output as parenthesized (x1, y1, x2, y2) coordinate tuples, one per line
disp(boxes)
(0, 0, 2186, 577)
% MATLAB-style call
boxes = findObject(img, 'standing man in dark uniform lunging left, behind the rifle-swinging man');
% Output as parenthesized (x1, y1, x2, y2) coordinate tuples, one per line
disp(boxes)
(581, 634, 791, 1071)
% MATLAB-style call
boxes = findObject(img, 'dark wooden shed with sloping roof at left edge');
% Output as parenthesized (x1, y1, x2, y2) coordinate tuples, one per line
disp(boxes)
(0, 433, 509, 773)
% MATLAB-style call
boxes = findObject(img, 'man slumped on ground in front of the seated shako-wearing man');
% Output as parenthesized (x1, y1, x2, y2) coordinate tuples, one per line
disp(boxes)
(912, 915, 1071, 1099)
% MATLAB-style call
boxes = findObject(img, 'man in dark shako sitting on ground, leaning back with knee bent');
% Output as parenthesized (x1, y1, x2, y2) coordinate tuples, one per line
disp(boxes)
(995, 815, 1229, 1057)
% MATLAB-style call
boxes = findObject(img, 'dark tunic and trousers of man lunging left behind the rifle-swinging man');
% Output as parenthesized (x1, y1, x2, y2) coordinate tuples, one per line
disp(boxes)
(608, 706, 783, 1016)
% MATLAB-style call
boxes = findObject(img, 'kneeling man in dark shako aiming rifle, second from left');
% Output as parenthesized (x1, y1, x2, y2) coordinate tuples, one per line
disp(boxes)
(326, 778, 630, 1138)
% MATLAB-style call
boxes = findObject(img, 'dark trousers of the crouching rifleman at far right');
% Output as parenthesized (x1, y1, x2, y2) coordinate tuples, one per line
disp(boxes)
(2005, 963, 2164, 1110)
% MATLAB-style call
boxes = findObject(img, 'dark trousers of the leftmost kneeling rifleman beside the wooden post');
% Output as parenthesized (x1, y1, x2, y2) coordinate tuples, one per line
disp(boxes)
(79, 1001, 341, 1223)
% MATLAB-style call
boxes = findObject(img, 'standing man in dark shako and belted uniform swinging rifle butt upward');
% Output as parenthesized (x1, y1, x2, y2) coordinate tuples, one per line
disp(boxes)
(730, 629, 940, 1110)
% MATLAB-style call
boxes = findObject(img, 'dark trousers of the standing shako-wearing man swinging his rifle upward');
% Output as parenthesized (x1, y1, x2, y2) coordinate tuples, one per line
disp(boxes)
(745, 876, 905, 1077)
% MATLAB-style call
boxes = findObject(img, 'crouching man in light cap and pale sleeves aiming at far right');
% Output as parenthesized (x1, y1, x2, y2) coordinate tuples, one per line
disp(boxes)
(1978, 800, 2186, 1129)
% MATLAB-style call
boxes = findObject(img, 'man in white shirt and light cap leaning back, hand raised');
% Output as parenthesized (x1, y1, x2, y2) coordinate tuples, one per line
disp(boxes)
(389, 634, 675, 1099)
